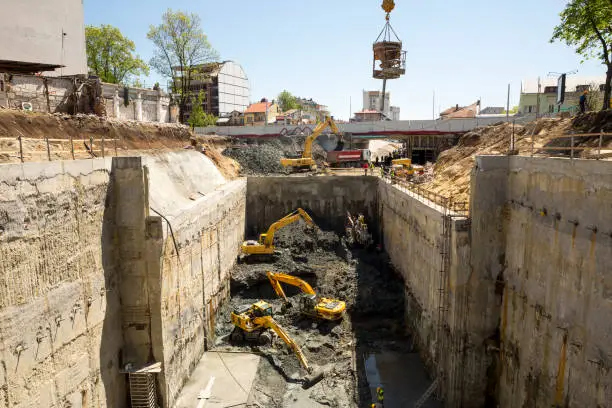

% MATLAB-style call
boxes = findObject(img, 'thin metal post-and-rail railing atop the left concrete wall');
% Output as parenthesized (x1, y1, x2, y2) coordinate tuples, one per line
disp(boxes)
(0, 136, 119, 163)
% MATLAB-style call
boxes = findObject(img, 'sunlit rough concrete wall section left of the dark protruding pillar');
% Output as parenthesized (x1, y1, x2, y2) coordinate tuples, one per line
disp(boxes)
(0, 159, 125, 407)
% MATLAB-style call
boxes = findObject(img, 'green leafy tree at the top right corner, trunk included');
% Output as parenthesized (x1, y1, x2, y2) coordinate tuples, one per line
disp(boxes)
(550, 0, 612, 109)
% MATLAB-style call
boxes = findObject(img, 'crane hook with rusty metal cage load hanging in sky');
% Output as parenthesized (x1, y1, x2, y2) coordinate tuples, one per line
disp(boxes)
(372, 0, 406, 115)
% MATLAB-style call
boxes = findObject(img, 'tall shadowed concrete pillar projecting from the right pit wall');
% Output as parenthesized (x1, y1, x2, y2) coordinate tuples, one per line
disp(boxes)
(462, 156, 509, 406)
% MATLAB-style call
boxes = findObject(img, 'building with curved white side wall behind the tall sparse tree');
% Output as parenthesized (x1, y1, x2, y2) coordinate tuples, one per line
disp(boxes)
(174, 61, 251, 120)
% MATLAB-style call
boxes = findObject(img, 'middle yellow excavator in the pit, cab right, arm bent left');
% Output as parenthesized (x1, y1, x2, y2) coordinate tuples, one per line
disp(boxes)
(266, 271, 346, 320)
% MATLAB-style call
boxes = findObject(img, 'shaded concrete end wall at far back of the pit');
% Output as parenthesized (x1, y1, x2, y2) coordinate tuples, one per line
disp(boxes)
(246, 176, 378, 238)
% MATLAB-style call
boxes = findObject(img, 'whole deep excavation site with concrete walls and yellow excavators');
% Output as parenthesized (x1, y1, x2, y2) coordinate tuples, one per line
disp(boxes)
(0, 0, 612, 408)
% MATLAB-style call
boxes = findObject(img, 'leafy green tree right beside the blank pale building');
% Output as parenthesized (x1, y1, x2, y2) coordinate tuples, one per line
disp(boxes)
(85, 24, 149, 84)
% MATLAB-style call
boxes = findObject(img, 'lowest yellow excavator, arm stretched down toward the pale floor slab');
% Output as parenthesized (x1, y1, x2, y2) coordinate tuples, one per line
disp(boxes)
(230, 300, 324, 388)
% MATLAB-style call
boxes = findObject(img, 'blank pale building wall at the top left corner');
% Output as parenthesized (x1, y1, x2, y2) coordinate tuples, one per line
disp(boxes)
(0, 0, 87, 76)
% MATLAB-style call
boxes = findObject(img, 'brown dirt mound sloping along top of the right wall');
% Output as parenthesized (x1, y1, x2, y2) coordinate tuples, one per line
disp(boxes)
(423, 111, 612, 202)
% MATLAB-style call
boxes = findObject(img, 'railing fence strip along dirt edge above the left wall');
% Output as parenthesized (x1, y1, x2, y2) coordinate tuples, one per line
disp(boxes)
(0, 136, 119, 163)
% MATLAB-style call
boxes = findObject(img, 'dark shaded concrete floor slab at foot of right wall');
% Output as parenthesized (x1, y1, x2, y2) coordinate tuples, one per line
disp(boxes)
(364, 351, 442, 408)
